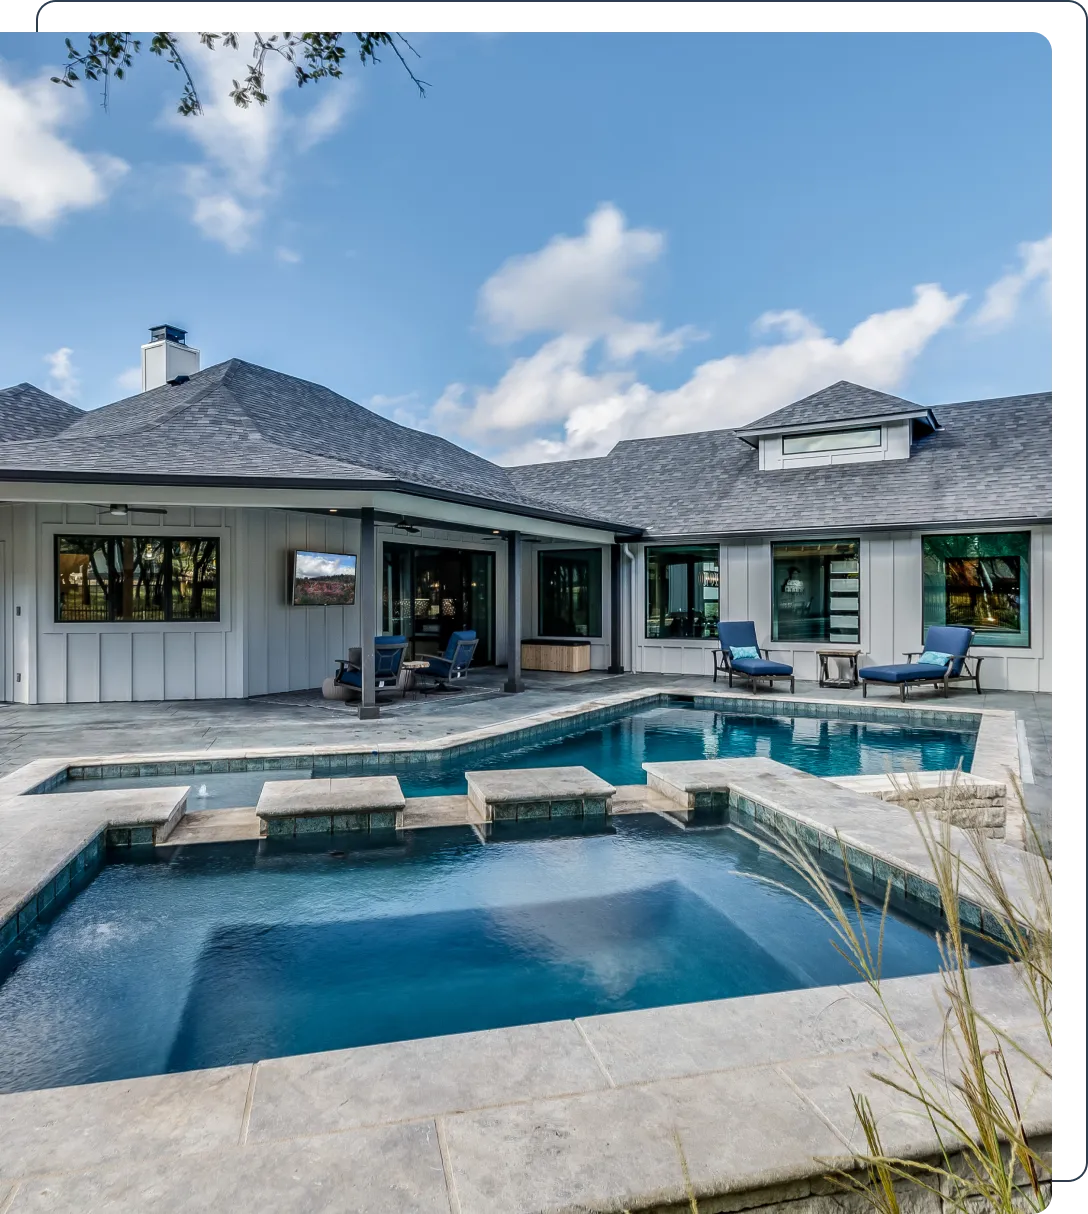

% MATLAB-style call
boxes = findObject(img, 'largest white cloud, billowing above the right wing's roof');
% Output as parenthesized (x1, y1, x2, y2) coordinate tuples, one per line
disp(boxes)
(429, 205, 967, 463)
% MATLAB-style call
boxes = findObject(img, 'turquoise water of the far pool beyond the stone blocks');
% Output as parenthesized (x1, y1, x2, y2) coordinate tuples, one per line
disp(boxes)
(51, 704, 976, 810)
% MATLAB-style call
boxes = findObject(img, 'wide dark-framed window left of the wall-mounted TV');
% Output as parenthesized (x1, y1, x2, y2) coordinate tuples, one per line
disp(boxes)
(53, 535, 220, 624)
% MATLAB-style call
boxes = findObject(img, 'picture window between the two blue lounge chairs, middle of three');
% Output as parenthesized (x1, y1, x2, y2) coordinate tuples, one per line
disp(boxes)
(771, 539, 861, 645)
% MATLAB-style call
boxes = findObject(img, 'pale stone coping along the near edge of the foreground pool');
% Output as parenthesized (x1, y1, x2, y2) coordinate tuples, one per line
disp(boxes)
(0, 966, 1055, 1214)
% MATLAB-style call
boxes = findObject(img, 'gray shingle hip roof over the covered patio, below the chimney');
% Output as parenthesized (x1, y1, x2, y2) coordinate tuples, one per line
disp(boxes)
(0, 358, 631, 522)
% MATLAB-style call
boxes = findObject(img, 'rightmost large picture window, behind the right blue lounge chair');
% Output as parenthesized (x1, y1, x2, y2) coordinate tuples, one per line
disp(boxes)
(922, 532, 1031, 648)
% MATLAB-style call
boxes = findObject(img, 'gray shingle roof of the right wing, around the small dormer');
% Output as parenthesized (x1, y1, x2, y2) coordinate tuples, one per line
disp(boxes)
(510, 392, 1054, 537)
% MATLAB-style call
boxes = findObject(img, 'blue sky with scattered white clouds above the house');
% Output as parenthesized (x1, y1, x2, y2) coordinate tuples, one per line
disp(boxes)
(0, 34, 1054, 461)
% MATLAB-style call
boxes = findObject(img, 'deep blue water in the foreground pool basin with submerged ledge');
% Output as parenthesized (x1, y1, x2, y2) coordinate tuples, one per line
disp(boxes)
(0, 815, 990, 1091)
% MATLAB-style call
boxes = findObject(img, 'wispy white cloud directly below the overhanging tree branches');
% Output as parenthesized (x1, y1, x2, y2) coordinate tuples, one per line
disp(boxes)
(164, 34, 356, 253)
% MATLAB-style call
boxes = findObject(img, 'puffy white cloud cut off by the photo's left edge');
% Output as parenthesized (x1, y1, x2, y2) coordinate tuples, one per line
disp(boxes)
(0, 74, 129, 236)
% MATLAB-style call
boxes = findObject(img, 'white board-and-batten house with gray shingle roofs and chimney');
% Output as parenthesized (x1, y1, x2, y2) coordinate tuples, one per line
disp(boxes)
(0, 325, 1056, 715)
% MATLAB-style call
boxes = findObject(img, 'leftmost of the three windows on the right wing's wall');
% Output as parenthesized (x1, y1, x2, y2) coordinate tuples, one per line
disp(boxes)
(646, 544, 720, 640)
